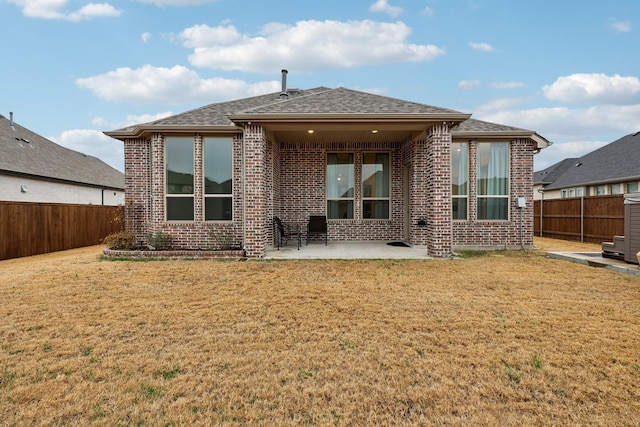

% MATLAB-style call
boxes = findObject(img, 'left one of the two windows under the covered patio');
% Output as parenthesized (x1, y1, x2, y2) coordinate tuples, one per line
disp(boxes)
(327, 153, 355, 219)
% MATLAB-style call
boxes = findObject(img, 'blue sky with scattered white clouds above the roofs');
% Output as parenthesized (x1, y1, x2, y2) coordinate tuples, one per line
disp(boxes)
(0, 0, 640, 174)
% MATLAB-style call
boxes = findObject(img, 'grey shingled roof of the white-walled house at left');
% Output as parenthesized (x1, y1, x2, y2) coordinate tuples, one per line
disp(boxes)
(0, 115, 124, 190)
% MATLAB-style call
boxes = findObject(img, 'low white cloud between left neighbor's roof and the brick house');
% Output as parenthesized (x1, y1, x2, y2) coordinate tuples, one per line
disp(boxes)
(47, 129, 124, 171)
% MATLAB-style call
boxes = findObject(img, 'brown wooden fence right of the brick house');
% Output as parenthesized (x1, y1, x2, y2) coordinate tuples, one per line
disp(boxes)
(533, 194, 624, 243)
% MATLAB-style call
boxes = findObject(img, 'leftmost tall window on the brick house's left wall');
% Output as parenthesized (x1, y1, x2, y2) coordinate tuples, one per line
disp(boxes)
(165, 137, 194, 221)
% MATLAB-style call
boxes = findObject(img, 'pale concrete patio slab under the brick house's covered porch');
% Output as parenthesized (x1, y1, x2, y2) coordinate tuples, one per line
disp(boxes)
(264, 241, 432, 260)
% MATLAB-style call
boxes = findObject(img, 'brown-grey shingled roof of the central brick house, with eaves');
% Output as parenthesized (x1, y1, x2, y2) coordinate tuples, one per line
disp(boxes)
(105, 87, 551, 148)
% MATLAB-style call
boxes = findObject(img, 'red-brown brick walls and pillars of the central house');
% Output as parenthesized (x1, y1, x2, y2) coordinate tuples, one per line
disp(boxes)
(124, 125, 535, 257)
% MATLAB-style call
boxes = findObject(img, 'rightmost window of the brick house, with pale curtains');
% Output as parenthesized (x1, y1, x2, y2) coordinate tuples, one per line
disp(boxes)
(477, 142, 509, 220)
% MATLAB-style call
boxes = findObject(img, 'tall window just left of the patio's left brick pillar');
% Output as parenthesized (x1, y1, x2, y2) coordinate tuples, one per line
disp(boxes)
(204, 137, 233, 221)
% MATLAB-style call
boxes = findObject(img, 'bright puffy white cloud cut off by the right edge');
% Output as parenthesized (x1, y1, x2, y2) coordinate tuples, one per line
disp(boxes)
(542, 74, 640, 104)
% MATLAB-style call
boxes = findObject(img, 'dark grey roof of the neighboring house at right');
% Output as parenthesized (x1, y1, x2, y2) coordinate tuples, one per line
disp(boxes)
(545, 132, 640, 190)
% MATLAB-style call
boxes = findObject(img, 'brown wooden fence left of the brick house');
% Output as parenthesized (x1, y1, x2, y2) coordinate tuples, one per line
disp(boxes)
(0, 202, 122, 260)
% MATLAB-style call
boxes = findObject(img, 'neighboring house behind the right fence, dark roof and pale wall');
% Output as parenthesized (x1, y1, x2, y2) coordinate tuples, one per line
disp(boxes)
(534, 132, 640, 200)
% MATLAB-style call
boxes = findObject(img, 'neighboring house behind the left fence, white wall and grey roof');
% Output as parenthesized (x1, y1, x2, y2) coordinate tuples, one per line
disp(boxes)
(0, 113, 124, 206)
